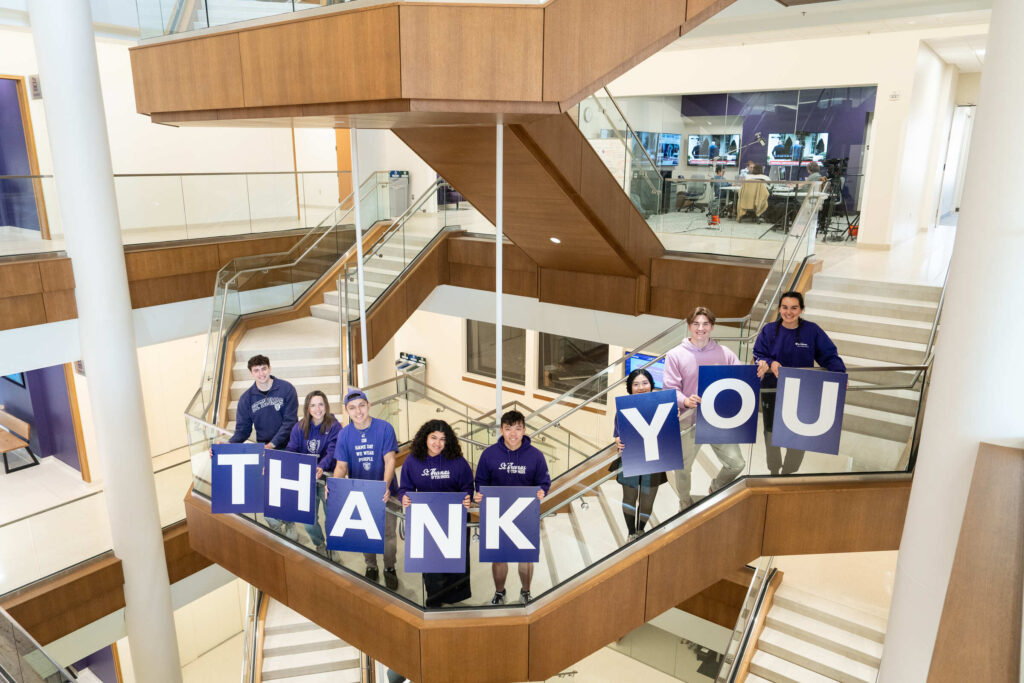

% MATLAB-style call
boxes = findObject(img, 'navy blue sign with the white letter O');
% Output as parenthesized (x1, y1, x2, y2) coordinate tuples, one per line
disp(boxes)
(693, 366, 761, 443)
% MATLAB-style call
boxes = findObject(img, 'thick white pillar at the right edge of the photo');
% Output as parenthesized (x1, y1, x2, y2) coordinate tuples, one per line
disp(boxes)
(879, 0, 1024, 683)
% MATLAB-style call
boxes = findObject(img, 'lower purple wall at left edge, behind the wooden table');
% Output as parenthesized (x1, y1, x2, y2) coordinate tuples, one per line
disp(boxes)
(0, 366, 81, 471)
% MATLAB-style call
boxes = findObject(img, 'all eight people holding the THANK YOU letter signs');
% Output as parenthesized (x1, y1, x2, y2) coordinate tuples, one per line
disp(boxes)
(230, 292, 846, 607)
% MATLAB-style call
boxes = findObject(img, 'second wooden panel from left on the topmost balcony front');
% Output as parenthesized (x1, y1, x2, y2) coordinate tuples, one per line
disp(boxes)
(237, 5, 401, 109)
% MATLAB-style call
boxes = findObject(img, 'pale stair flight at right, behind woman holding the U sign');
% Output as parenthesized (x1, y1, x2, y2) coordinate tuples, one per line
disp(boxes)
(806, 274, 942, 443)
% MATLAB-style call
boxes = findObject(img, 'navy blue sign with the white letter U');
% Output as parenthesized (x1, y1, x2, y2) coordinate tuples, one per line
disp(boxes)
(771, 368, 847, 456)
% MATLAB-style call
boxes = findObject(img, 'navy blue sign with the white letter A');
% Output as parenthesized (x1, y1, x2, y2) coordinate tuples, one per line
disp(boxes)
(326, 477, 386, 555)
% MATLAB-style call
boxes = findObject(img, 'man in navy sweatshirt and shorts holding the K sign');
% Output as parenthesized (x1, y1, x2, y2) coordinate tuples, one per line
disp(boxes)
(475, 411, 551, 605)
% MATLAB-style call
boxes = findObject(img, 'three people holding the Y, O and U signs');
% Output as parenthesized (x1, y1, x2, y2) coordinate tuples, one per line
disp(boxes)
(609, 292, 846, 540)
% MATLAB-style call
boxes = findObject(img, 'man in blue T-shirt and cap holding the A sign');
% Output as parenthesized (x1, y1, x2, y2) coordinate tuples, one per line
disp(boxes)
(334, 389, 398, 591)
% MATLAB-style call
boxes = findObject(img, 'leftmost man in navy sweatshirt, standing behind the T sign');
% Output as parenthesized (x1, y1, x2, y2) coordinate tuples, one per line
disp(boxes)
(228, 354, 299, 541)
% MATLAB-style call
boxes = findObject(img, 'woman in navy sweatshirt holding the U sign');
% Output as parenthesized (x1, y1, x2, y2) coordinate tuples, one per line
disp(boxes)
(754, 292, 846, 475)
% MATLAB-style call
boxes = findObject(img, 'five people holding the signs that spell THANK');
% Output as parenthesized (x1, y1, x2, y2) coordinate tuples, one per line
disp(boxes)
(229, 355, 551, 607)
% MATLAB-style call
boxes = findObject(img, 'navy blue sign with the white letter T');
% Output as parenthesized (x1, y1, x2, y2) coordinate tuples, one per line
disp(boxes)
(210, 443, 263, 513)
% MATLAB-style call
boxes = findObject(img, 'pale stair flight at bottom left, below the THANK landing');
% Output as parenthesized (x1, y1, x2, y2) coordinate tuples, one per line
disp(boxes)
(257, 598, 359, 683)
